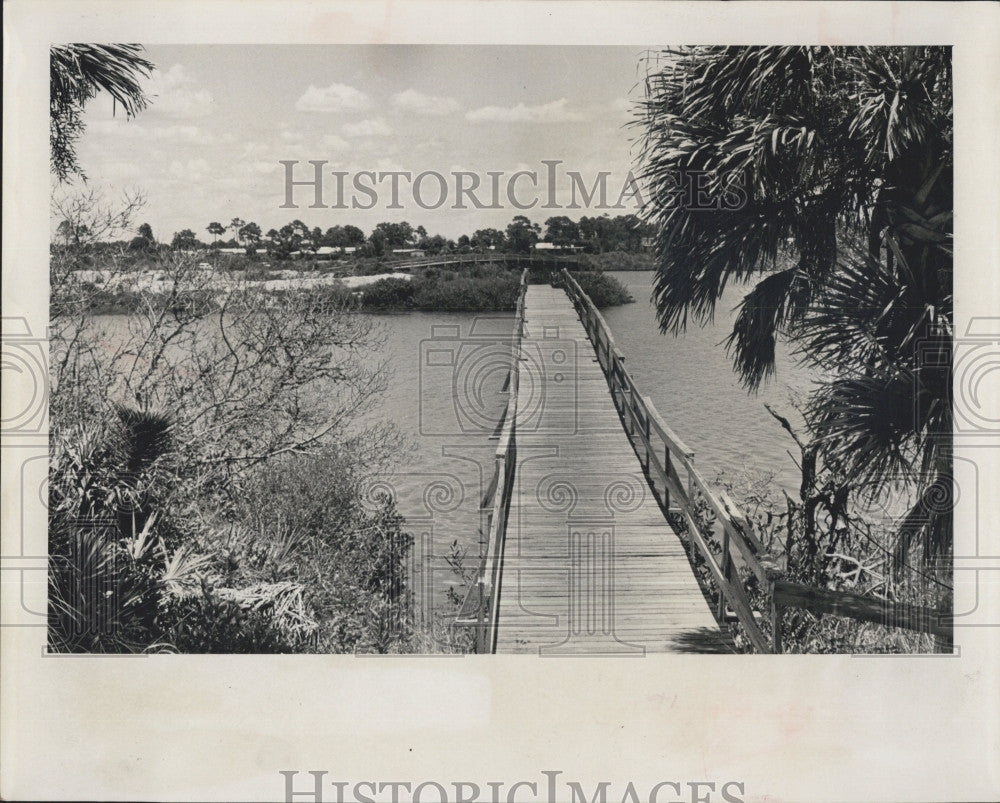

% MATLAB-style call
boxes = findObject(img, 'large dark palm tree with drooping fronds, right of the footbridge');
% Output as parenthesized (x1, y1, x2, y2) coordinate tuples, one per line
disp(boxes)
(641, 47, 952, 564)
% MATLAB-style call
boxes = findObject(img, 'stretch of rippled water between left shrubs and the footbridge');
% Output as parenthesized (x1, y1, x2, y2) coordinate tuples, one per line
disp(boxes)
(362, 312, 514, 611)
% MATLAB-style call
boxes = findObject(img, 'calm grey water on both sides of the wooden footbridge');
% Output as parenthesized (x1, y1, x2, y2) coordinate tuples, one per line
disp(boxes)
(78, 282, 809, 611)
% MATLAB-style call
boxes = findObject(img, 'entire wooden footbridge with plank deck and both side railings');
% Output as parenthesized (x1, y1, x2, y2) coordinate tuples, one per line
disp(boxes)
(455, 268, 950, 655)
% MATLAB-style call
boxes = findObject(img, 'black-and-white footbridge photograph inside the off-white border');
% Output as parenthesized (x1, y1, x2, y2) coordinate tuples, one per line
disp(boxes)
(47, 43, 952, 657)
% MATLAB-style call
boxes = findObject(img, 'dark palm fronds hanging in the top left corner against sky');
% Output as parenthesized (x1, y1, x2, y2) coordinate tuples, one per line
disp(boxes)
(49, 44, 155, 181)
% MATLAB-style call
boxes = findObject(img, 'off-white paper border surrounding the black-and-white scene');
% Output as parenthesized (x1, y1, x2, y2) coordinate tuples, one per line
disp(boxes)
(0, 0, 1000, 801)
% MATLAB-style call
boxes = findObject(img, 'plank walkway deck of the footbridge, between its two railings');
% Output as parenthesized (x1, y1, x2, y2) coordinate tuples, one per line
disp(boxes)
(497, 285, 733, 655)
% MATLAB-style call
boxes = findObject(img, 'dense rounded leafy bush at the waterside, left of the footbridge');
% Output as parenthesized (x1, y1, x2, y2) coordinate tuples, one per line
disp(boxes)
(231, 450, 415, 653)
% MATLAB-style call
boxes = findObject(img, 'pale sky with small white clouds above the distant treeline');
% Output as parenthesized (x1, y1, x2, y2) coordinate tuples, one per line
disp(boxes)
(72, 45, 664, 240)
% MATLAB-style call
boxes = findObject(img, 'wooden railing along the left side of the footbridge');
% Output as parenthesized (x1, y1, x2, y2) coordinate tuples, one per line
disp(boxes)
(454, 268, 528, 653)
